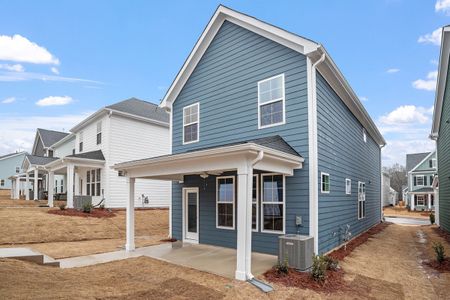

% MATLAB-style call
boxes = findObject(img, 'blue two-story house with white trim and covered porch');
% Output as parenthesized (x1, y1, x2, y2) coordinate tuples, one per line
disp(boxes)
(115, 6, 385, 280)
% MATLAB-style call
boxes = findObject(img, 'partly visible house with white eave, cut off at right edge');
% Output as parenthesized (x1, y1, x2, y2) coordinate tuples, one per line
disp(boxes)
(430, 26, 450, 232)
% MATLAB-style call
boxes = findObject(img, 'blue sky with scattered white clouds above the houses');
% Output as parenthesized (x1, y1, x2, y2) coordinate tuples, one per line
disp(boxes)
(0, 0, 444, 165)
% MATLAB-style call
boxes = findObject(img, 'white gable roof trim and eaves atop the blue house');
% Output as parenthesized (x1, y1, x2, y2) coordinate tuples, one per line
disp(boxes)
(160, 5, 386, 146)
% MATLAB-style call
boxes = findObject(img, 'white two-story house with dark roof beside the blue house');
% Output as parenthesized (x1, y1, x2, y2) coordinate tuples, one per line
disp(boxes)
(24, 98, 171, 208)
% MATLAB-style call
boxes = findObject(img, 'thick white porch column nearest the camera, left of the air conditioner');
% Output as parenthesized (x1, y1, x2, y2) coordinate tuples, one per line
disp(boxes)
(235, 162, 253, 280)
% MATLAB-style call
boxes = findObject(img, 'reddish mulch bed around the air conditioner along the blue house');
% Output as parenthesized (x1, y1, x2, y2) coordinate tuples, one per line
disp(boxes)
(263, 222, 392, 293)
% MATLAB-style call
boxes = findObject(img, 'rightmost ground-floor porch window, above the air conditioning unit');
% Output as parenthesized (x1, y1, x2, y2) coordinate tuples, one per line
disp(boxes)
(261, 174, 285, 233)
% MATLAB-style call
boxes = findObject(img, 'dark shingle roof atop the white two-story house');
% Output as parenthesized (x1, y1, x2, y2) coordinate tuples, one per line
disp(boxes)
(106, 98, 169, 123)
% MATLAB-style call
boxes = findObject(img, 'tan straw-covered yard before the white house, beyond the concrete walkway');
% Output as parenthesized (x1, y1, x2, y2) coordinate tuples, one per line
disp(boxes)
(0, 200, 168, 258)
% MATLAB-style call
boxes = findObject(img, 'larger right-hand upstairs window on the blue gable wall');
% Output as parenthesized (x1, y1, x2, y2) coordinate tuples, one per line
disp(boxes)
(258, 74, 285, 128)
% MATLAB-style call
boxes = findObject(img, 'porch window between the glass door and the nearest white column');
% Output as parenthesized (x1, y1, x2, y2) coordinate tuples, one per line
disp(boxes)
(216, 176, 235, 229)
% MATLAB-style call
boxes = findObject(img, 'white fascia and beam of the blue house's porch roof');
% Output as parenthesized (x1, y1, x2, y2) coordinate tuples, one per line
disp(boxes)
(113, 143, 304, 180)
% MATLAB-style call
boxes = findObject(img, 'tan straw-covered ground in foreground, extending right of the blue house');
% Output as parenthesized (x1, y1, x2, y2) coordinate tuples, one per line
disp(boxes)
(0, 221, 450, 299)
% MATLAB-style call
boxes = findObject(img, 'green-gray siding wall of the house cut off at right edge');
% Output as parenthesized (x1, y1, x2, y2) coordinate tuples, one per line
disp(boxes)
(437, 59, 450, 232)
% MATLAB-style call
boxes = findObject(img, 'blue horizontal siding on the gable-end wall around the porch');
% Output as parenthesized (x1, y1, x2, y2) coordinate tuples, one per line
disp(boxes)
(172, 22, 309, 253)
